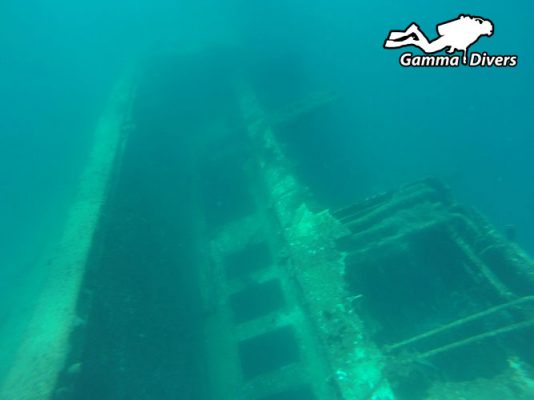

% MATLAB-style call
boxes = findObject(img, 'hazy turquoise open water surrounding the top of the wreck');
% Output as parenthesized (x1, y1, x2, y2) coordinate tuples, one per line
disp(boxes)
(0, 0, 534, 390)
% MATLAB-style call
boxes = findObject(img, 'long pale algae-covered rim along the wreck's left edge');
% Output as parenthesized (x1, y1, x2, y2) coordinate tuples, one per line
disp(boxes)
(0, 78, 133, 399)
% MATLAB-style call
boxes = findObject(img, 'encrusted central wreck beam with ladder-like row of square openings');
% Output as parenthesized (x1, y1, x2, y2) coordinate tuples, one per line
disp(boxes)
(202, 89, 394, 400)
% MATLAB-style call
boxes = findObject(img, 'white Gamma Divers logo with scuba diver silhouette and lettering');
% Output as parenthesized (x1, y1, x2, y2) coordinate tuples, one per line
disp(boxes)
(384, 14, 518, 67)
